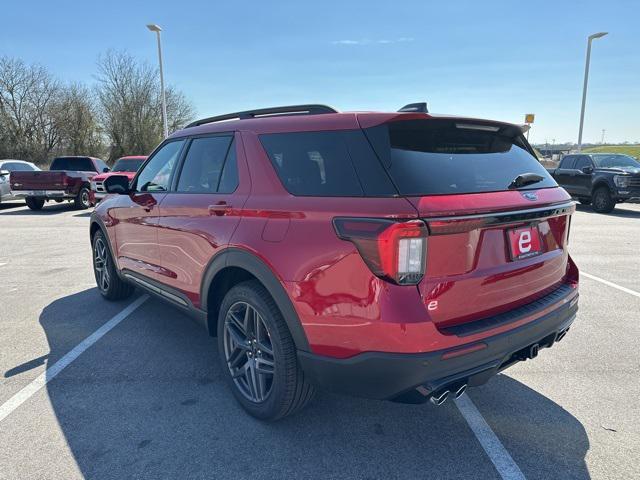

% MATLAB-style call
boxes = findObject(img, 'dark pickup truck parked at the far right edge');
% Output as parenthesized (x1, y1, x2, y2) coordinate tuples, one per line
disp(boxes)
(548, 153, 640, 213)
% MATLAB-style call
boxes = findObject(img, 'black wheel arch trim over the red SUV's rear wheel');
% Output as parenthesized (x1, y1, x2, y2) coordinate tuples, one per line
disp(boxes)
(200, 247, 310, 351)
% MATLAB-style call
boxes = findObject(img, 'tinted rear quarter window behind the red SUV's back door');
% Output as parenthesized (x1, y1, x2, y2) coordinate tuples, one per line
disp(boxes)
(260, 130, 397, 197)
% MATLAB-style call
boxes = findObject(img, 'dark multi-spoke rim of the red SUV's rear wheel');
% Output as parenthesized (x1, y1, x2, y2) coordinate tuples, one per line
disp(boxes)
(224, 302, 275, 403)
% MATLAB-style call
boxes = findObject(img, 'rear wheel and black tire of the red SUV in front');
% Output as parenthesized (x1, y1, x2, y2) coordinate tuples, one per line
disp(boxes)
(218, 280, 315, 421)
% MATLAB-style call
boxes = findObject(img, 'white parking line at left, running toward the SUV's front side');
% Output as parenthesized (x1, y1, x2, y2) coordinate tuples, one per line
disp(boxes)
(0, 295, 149, 422)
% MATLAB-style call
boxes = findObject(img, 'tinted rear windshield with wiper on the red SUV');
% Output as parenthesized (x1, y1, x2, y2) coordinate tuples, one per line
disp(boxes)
(365, 120, 557, 195)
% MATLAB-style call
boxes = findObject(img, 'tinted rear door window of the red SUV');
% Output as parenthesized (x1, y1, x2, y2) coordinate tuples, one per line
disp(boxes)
(177, 136, 232, 193)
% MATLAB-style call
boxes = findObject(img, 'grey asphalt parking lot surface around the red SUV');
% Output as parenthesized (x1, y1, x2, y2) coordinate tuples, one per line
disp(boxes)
(0, 203, 640, 479)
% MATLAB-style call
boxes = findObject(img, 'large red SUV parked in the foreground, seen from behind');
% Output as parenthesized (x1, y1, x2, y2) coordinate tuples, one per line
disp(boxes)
(90, 104, 578, 420)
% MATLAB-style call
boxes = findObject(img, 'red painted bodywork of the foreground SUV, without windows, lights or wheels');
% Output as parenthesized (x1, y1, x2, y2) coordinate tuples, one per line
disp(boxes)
(92, 109, 578, 402)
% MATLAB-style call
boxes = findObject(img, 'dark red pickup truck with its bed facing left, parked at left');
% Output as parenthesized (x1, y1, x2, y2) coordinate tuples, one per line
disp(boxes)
(11, 156, 109, 210)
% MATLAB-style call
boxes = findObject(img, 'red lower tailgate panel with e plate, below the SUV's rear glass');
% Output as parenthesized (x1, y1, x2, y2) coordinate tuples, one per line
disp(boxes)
(414, 188, 575, 327)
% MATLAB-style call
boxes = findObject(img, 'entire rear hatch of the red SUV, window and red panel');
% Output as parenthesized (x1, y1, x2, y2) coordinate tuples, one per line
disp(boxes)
(364, 117, 575, 328)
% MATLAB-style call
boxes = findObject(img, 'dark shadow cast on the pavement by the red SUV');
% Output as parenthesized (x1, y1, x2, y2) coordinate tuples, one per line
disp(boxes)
(30, 289, 589, 480)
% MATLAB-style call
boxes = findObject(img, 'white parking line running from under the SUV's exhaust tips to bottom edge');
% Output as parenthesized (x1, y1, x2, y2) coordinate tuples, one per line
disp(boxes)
(455, 395, 525, 480)
